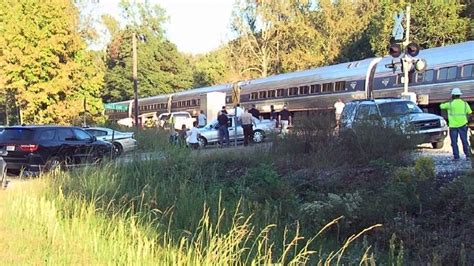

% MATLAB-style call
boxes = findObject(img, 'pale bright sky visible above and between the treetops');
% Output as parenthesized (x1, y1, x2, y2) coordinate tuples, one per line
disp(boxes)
(90, 0, 234, 54)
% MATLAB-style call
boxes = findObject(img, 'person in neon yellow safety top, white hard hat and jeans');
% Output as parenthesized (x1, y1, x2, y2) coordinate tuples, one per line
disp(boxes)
(439, 88, 472, 160)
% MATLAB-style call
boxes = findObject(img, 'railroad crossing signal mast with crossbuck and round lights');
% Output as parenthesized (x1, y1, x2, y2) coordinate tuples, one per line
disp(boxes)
(385, 6, 427, 103)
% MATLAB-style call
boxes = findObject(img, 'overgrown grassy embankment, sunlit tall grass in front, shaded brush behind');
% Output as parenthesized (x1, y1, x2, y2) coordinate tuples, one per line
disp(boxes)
(2, 115, 474, 265)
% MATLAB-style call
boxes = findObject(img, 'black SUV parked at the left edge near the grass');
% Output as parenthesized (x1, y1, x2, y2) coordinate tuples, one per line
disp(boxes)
(0, 126, 113, 174)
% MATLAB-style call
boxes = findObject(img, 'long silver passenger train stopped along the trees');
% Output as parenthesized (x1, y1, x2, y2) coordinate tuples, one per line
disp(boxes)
(106, 41, 474, 121)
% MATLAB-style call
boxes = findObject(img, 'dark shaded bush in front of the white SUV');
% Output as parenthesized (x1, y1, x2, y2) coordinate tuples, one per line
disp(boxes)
(273, 114, 417, 168)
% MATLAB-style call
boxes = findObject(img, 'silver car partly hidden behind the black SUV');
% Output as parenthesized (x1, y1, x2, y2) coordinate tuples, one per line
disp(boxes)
(85, 127, 138, 156)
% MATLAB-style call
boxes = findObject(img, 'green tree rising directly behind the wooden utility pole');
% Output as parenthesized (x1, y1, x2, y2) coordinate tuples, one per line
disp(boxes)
(103, 1, 193, 102)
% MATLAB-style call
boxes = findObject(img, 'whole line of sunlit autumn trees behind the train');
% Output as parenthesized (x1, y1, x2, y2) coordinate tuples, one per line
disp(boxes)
(0, 0, 474, 124)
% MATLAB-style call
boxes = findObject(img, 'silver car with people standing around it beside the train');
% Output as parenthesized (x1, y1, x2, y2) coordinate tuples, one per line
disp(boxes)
(193, 116, 276, 147)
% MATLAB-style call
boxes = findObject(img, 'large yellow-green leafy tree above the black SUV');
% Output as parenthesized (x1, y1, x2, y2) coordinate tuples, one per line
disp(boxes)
(0, 0, 103, 124)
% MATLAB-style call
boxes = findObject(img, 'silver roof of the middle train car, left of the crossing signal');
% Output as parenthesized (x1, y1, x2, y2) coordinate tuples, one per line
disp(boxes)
(242, 58, 375, 88)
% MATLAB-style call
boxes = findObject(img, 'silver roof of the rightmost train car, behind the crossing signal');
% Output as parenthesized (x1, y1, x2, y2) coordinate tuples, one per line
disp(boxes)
(376, 41, 474, 73)
